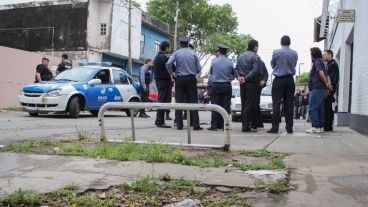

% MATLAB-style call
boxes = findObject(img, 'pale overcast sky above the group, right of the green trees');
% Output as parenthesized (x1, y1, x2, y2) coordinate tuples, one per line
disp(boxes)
(137, 0, 323, 75)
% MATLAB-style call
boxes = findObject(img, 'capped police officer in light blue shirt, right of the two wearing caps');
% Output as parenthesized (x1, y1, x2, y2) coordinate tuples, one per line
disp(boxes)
(207, 44, 235, 131)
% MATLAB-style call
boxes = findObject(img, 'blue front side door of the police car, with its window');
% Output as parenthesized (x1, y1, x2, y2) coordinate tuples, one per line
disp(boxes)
(87, 69, 114, 109)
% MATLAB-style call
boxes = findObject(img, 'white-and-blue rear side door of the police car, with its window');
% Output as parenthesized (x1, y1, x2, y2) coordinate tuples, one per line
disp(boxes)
(112, 69, 137, 102)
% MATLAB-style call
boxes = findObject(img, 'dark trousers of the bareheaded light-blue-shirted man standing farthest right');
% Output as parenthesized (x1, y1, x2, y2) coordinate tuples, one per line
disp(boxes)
(272, 76, 295, 131)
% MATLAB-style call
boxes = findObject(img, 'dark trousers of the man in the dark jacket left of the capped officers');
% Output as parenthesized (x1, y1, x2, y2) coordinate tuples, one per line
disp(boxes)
(155, 80, 172, 125)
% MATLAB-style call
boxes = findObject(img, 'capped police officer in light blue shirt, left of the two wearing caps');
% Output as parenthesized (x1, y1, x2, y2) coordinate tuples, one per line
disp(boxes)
(166, 37, 202, 130)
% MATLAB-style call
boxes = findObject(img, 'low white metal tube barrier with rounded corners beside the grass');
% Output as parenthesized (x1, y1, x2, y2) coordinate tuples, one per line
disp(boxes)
(98, 102, 230, 150)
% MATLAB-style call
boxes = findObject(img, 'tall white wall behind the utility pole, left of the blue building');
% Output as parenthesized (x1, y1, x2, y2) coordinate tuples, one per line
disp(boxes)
(111, 0, 142, 59)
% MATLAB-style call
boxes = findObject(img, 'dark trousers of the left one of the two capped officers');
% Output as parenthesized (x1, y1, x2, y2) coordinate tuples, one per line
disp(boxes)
(175, 75, 199, 129)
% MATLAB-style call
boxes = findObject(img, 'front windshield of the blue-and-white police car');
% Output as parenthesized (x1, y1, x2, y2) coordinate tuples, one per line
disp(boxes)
(55, 67, 95, 82)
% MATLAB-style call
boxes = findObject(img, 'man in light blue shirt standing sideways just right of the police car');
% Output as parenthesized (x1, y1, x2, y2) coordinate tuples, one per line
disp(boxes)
(139, 59, 153, 118)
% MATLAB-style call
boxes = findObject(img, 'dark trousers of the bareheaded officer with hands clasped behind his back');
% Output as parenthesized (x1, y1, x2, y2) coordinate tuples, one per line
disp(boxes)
(240, 82, 258, 130)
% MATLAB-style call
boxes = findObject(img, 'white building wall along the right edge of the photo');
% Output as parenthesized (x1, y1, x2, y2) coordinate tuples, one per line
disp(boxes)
(330, 0, 368, 115)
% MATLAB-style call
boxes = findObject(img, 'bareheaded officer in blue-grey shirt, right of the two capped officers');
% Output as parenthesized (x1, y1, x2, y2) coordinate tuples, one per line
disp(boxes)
(235, 39, 259, 132)
